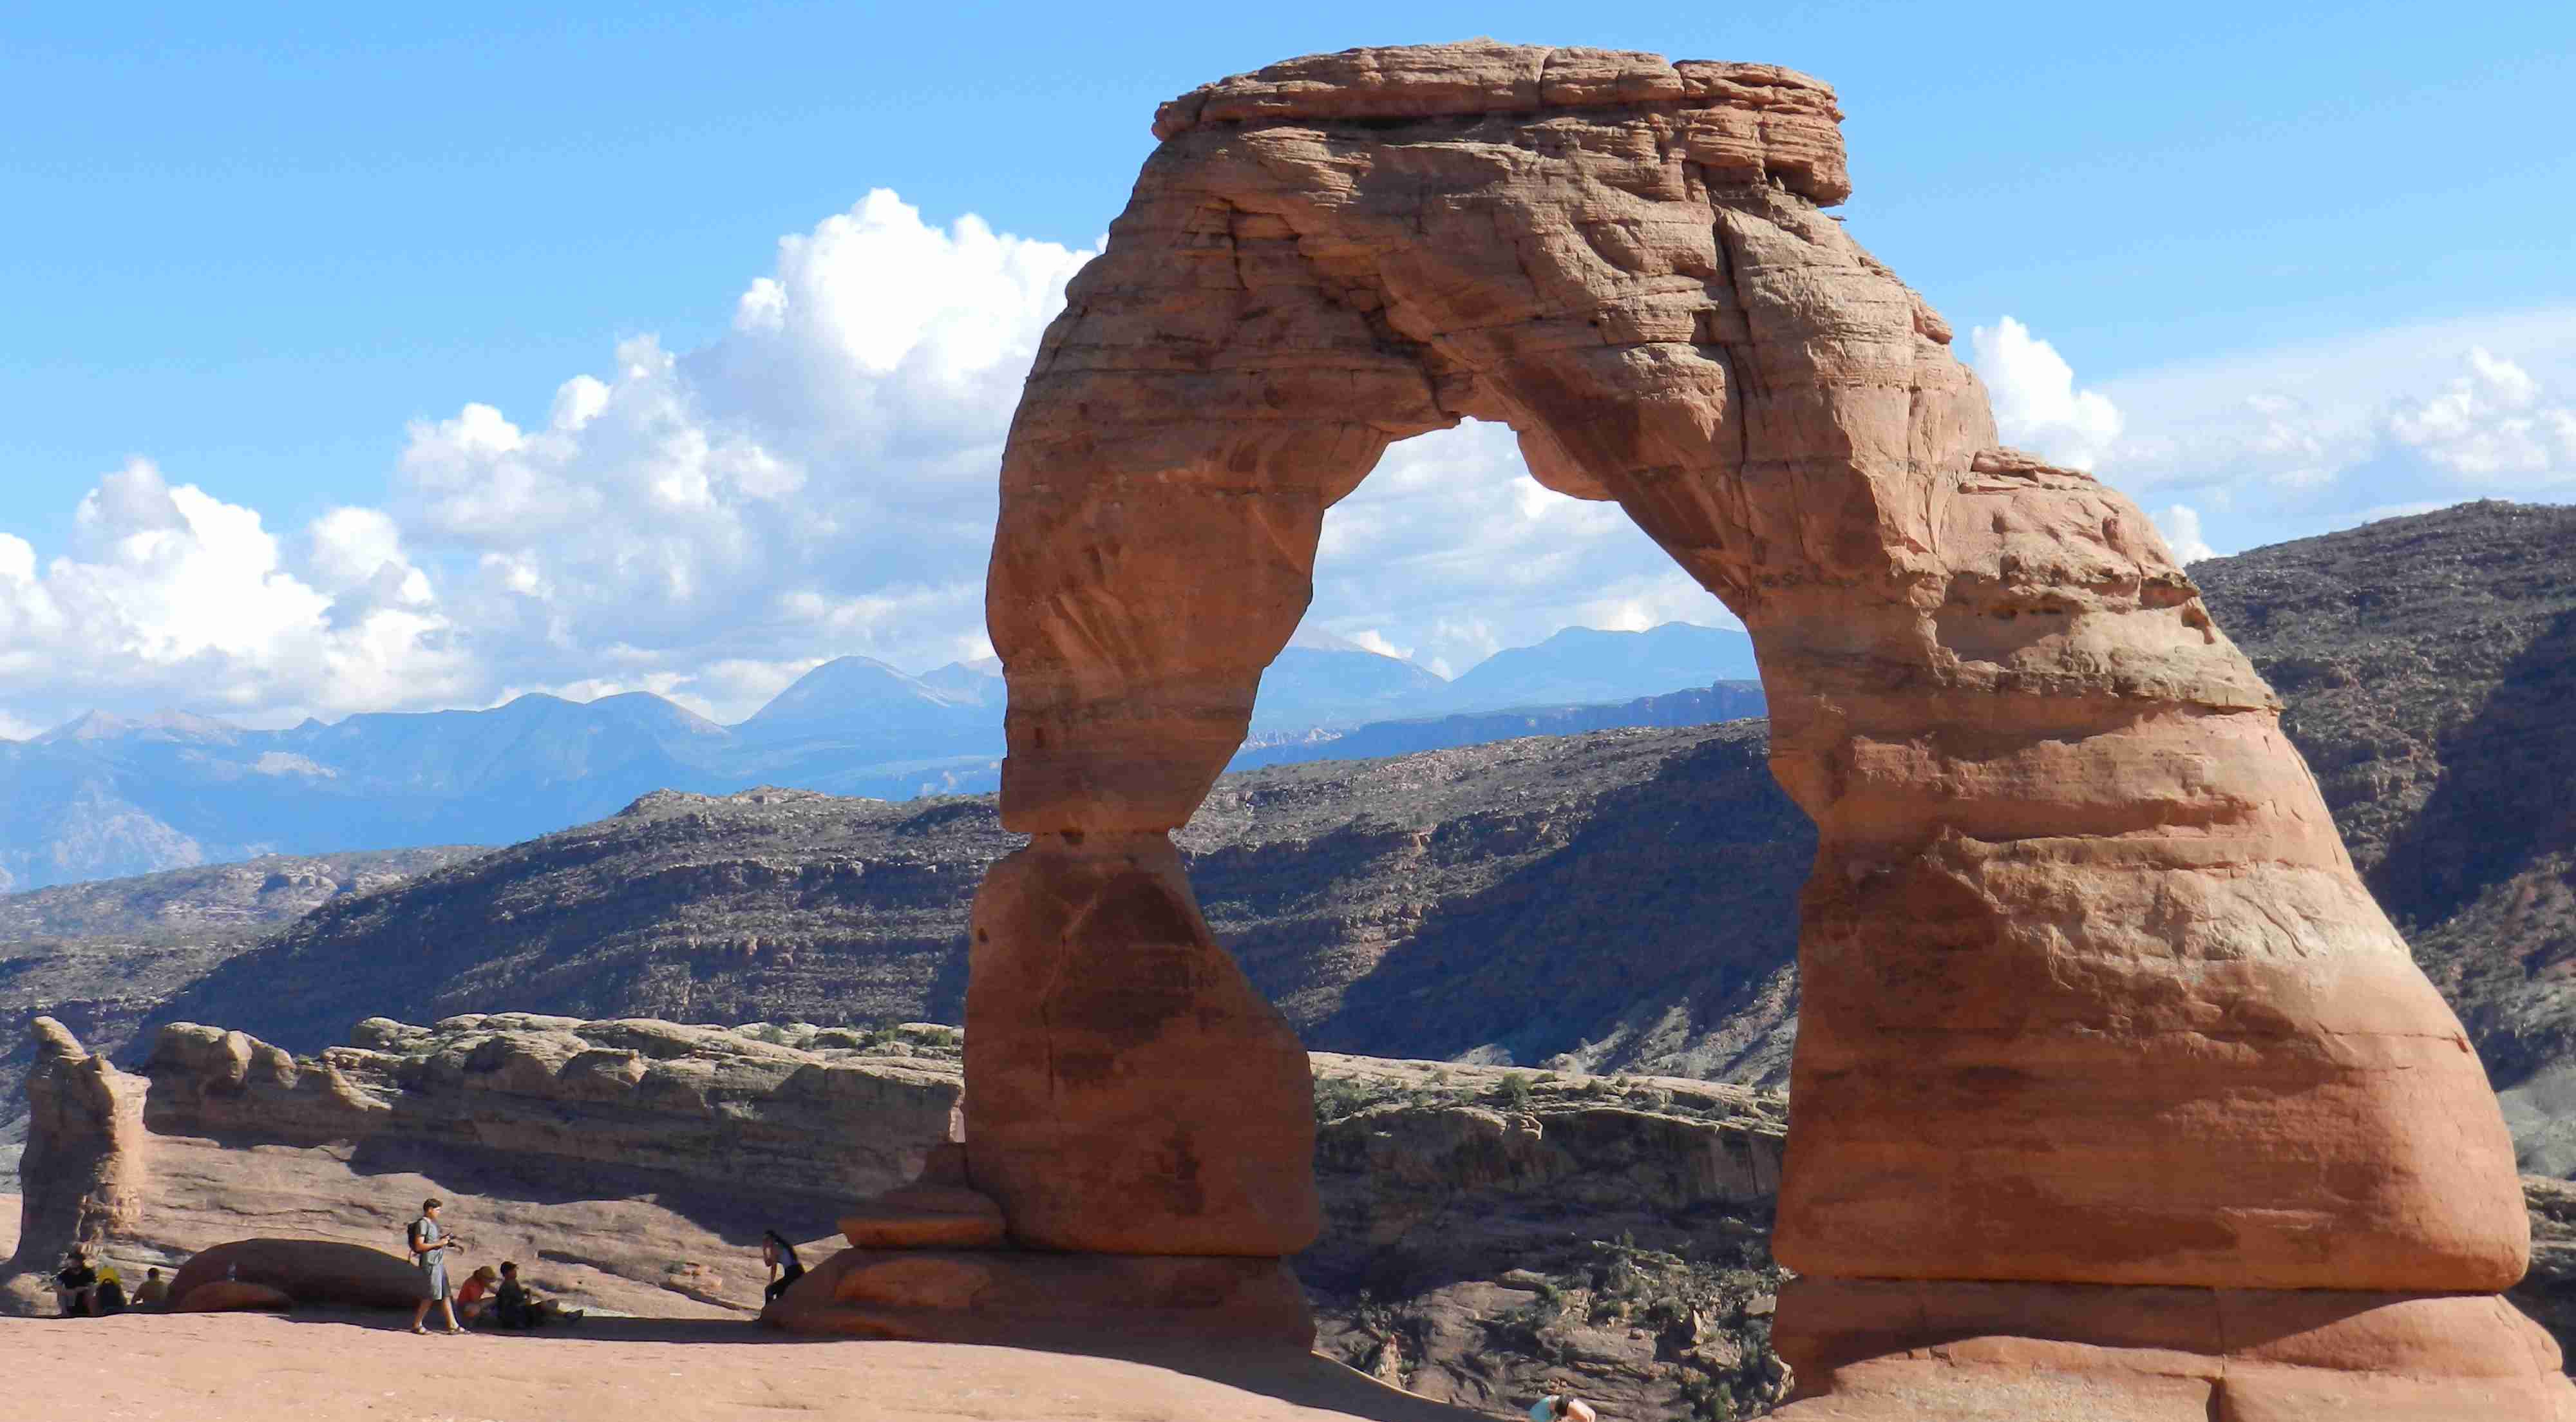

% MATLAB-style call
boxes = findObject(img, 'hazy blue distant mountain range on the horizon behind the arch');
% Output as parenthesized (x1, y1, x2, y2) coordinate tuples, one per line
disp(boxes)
(0, 623, 1759, 894)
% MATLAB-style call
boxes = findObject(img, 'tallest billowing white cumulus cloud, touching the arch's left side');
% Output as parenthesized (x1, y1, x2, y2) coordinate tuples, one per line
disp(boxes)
(394, 191, 1090, 719)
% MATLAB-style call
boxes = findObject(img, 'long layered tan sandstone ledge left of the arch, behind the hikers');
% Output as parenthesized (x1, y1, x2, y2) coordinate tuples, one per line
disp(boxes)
(0, 1012, 958, 1319)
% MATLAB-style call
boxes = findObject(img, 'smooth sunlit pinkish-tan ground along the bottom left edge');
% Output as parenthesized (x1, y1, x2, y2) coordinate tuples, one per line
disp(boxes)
(0, 1314, 1489, 1422)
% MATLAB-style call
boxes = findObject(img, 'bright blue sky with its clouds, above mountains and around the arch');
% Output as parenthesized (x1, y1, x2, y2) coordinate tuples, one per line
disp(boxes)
(0, 3, 2576, 734)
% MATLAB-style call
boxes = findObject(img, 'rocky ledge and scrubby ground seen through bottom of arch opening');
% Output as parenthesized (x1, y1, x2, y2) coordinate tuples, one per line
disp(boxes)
(1296, 1054, 1788, 1417)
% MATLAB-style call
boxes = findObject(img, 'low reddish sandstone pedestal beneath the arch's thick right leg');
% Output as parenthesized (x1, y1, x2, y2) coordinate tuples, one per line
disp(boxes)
(1772, 1278, 2576, 1422)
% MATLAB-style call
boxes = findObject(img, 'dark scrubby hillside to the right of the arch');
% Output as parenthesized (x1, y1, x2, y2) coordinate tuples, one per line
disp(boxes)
(2192, 502, 2576, 1175)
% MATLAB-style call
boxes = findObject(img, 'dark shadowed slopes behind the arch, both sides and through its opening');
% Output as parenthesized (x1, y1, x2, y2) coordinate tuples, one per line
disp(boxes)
(61, 502, 2576, 1172)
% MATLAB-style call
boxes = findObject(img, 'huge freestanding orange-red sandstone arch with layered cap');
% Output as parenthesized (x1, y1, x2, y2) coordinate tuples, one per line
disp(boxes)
(966, 41, 2576, 1417)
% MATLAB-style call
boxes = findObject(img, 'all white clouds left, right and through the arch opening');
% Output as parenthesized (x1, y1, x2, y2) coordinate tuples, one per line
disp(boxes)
(25, 191, 2576, 737)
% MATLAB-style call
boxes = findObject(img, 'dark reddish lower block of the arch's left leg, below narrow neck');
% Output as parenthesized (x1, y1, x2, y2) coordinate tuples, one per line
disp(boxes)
(966, 832, 1316, 1257)
